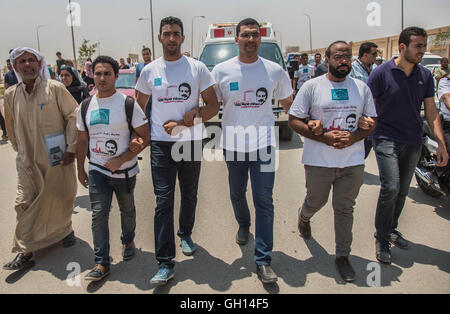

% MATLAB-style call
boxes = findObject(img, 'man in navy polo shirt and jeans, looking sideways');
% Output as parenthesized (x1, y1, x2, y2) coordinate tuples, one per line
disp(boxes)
(368, 27, 448, 263)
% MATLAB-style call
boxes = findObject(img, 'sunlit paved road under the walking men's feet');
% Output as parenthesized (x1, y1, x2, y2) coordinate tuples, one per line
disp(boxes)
(0, 131, 450, 294)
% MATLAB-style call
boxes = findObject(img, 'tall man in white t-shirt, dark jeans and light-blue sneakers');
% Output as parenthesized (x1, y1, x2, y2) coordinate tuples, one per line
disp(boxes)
(136, 17, 219, 285)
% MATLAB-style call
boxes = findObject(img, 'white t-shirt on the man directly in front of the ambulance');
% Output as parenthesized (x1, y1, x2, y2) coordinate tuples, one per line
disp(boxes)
(212, 57, 292, 152)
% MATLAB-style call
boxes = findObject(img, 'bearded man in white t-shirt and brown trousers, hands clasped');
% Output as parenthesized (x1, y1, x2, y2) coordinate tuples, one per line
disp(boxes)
(289, 41, 376, 282)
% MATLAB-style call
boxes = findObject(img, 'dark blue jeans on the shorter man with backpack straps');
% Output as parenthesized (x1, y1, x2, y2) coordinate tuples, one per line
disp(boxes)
(89, 170, 136, 265)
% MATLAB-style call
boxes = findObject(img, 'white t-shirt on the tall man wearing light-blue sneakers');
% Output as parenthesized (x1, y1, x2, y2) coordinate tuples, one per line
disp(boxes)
(136, 56, 214, 142)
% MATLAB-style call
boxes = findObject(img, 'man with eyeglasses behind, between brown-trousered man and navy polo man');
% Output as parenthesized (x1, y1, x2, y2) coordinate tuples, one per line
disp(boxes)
(350, 42, 378, 158)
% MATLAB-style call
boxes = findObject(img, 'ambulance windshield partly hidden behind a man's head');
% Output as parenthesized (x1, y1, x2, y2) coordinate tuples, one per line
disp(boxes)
(199, 42, 285, 71)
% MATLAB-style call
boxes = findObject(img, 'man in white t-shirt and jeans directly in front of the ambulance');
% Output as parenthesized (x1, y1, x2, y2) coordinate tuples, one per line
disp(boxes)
(212, 18, 292, 283)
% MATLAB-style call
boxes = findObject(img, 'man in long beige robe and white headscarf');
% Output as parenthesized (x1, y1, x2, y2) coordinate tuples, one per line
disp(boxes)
(3, 47, 77, 270)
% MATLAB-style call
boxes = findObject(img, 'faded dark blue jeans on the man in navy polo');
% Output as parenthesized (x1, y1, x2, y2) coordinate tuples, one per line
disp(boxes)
(373, 139, 422, 243)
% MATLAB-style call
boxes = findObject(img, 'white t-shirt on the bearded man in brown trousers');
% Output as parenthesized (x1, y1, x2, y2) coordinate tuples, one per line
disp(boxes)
(289, 75, 377, 168)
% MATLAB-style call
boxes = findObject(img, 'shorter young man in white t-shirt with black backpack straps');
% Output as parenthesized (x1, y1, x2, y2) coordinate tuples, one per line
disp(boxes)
(77, 56, 150, 281)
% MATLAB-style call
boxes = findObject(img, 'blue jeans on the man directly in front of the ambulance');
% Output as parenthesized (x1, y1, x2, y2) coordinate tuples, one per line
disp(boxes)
(224, 146, 275, 265)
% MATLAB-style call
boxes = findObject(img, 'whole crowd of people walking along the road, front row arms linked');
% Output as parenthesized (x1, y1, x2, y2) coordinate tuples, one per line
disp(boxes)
(0, 17, 450, 285)
